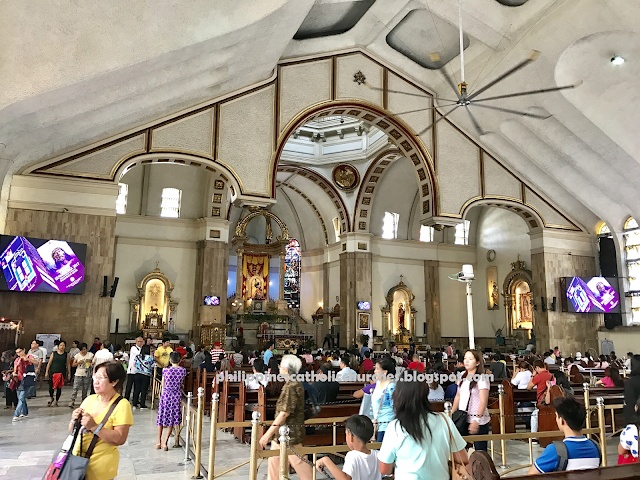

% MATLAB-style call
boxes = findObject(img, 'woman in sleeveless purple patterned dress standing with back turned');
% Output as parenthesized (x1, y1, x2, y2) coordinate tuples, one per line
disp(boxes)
(154, 352, 187, 451)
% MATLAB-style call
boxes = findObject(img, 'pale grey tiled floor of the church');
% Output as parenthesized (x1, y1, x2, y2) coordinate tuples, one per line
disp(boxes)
(0, 388, 617, 480)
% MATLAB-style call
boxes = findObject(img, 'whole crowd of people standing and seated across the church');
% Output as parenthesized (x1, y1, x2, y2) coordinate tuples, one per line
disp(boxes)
(1, 337, 640, 480)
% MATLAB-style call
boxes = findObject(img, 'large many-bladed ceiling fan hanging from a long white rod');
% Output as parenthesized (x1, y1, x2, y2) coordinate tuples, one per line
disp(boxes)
(364, 0, 582, 135)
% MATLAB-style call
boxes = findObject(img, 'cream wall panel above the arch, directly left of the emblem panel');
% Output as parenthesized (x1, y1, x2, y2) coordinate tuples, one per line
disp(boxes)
(278, 58, 332, 133)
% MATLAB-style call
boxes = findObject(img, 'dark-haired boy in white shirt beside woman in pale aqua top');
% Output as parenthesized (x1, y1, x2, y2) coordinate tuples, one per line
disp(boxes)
(316, 415, 382, 480)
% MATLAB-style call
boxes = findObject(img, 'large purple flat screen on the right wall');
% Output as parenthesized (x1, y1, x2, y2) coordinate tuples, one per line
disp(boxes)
(566, 277, 620, 313)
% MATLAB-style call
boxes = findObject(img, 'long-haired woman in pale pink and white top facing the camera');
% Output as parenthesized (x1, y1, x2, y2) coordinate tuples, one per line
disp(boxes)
(452, 350, 491, 451)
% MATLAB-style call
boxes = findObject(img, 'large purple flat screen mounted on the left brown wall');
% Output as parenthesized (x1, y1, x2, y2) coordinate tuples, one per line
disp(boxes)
(0, 235, 87, 294)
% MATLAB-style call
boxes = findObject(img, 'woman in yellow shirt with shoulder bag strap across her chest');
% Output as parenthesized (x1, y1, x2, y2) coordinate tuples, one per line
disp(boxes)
(69, 362, 133, 480)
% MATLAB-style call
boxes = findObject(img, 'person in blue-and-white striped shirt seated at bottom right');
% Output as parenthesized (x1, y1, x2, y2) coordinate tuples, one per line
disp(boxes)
(528, 397, 600, 475)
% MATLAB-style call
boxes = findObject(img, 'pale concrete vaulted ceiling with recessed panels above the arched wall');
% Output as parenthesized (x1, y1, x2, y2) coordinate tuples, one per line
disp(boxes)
(0, 0, 640, 230)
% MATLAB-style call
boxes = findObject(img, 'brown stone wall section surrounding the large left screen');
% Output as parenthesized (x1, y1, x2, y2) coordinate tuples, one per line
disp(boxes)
(0, 208, 116, 342)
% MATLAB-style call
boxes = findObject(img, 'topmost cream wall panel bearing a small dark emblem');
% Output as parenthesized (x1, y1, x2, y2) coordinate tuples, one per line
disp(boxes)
(335, 53, 384, 107)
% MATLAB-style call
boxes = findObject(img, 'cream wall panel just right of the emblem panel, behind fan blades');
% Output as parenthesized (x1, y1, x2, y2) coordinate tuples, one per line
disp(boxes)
(387, 72, 442, 157)
